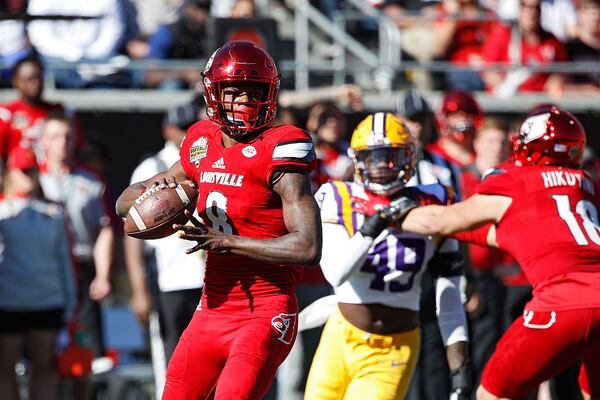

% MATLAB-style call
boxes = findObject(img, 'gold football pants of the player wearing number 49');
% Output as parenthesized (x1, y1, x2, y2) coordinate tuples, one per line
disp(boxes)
(304, 308, 421, 400)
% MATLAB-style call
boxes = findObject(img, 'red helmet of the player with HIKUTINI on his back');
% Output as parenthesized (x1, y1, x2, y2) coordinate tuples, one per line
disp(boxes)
(511, 106, 586, 167)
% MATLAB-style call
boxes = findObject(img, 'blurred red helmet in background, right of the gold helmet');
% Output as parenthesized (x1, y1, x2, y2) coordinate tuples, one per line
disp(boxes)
(435, 90, 483, 145)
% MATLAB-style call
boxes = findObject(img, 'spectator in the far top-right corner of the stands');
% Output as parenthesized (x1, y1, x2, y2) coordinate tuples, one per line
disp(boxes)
(567, 0, 600, 92)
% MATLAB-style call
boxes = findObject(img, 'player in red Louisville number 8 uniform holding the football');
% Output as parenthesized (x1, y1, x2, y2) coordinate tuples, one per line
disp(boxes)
(116, 41, 321, 400)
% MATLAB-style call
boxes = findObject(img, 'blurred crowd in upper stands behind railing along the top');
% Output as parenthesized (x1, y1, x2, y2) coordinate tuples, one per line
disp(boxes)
(0, 0, 600, 98)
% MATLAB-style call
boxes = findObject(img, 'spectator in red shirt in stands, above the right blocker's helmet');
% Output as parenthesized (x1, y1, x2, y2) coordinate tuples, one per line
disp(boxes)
(482, 0, 567, 98)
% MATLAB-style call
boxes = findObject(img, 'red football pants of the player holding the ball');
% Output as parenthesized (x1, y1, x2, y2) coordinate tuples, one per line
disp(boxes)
(162, 295, 298, 400)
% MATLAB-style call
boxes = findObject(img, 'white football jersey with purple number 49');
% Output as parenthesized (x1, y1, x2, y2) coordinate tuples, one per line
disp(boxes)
(315, 181, 458, 311)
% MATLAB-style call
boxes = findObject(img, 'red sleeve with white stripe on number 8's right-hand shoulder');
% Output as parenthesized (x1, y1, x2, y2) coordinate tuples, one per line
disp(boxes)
(265, 125, 317, 182)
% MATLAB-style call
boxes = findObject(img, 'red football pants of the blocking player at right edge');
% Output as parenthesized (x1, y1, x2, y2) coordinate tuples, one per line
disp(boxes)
(481, 308, 600, 399)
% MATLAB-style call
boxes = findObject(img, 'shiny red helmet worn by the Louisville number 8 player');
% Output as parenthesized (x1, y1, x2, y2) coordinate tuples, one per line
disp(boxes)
(202, 40, 279, 136)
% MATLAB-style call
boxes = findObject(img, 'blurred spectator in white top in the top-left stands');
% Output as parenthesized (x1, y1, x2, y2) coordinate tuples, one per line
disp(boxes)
(27, 0, 126, 88)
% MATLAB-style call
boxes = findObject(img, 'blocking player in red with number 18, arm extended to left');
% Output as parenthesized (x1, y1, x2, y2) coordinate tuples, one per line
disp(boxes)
(402, 107, 600, 400)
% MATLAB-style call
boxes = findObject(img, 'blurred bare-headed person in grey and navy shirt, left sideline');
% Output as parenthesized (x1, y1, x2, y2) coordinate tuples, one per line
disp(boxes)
(40, 114, 114, 357)
